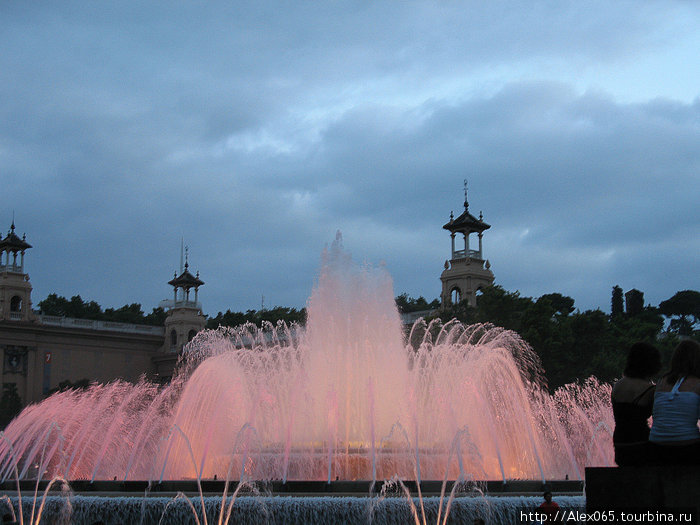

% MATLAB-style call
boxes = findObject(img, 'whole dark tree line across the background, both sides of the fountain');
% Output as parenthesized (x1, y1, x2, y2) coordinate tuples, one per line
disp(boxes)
(38, 286, 700, 389)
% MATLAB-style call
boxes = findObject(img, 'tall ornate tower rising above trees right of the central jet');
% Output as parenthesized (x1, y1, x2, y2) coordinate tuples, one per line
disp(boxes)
(440, 180, 493, 307)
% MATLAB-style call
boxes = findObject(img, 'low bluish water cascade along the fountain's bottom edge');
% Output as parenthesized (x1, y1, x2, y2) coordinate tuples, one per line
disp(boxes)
(2, 495, 585, 525)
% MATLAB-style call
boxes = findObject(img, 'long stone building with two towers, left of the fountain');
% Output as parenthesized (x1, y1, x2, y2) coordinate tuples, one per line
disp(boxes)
(0, 222, 205, 405)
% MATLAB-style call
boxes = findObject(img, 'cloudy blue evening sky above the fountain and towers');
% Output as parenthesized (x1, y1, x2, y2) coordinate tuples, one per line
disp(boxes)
(0, 0, 700, 315)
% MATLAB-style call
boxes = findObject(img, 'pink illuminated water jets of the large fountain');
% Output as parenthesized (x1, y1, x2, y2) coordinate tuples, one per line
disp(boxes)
(0, 235, 613, 480)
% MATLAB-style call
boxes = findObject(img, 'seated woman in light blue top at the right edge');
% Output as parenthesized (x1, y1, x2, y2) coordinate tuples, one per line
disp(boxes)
(649, 339, 700, 465)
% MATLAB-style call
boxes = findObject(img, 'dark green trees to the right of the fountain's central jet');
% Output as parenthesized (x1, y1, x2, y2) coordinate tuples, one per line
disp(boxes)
(434, 286, 700, 389)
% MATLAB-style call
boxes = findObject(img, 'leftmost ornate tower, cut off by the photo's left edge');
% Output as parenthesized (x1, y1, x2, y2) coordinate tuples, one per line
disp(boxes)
(0, 220, 35, 321)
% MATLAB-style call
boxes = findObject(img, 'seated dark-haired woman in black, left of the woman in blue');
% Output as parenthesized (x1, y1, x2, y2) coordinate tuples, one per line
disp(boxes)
(611, 343, 661, 467)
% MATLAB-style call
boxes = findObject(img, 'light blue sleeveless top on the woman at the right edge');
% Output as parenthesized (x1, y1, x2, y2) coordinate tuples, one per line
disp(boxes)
(649, 377, 700, 444)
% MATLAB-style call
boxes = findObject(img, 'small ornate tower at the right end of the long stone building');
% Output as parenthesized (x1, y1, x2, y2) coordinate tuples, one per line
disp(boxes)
(161, 249, 206, 353)
